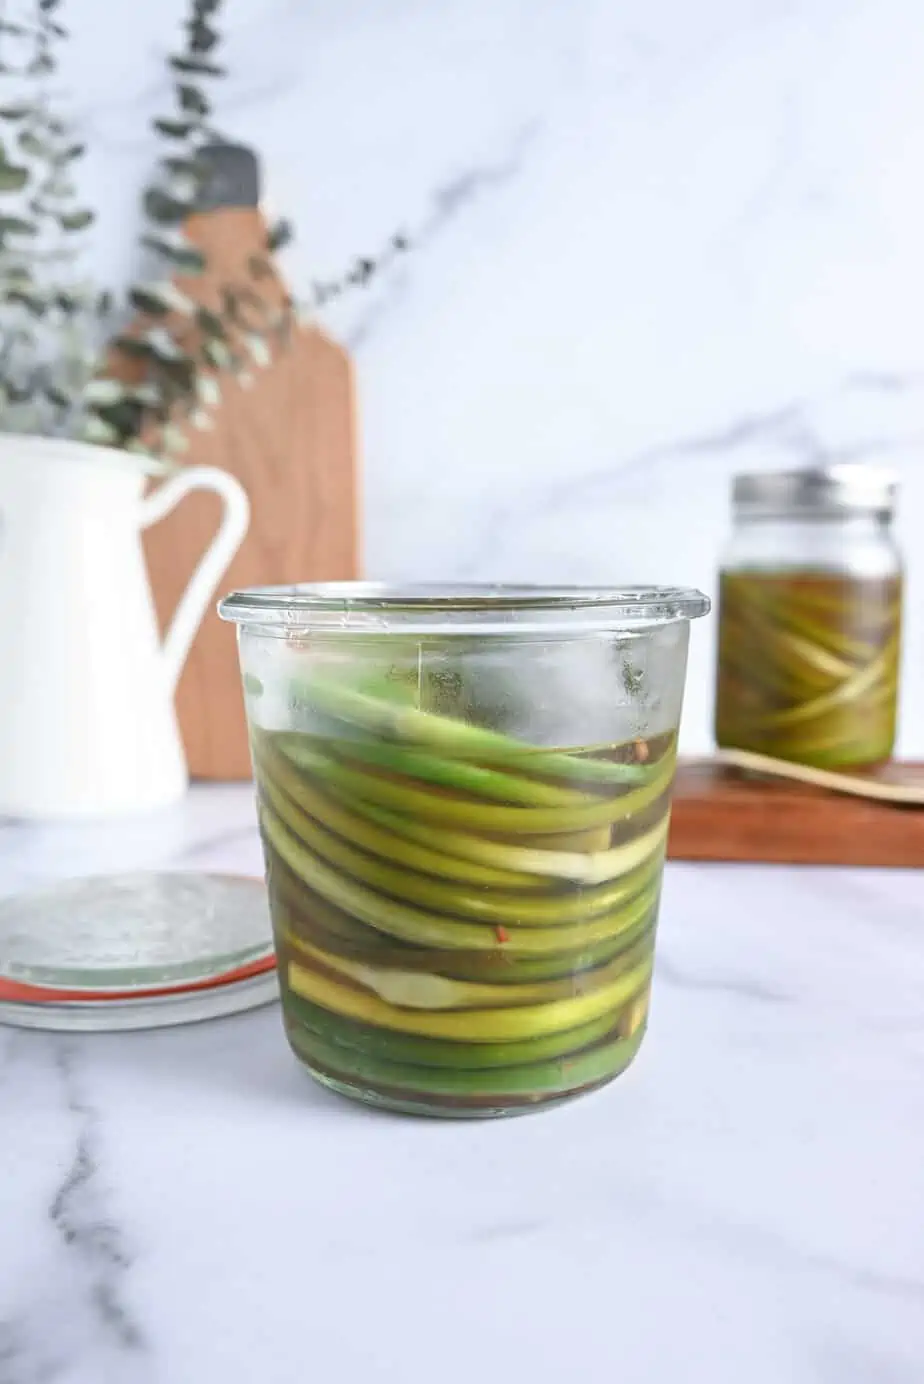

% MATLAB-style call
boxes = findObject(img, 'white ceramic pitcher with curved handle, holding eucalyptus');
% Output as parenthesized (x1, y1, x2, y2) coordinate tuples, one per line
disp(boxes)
(0, 435, 249, 818)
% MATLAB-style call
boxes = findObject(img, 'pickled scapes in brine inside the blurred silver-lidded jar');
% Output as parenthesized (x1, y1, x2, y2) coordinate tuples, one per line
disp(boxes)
(715, 572, 902, 768)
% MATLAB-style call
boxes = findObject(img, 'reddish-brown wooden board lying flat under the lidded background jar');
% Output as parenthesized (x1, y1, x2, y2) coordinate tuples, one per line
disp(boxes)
(668, 760, 924, 869)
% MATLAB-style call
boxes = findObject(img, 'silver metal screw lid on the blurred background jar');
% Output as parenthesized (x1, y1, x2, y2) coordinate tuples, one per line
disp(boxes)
(732, 465, 898, 519)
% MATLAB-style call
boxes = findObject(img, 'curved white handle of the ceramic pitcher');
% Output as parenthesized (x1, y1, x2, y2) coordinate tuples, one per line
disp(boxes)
(141, 466, 250, 693)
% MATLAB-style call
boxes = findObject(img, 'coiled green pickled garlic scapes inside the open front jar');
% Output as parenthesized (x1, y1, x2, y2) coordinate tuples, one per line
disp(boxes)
(253, 680, 675, 1111)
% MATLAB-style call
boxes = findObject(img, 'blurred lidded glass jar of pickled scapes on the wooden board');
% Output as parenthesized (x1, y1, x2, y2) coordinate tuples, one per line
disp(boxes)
(715, 466, 902, 768)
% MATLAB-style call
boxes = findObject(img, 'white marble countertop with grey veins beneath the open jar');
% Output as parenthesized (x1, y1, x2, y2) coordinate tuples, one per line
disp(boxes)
(0, 786, 924, 1384)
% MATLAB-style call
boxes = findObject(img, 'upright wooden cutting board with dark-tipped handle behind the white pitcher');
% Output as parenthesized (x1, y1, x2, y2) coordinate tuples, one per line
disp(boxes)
(127, 147, 360, 779)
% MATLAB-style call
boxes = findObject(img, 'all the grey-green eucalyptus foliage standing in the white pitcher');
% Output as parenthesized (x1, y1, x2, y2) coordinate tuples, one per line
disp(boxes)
(0, 0, 407, 455)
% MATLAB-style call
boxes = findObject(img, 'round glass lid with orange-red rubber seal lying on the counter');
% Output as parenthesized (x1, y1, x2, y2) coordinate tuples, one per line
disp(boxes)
(0, 871, 275, 1030)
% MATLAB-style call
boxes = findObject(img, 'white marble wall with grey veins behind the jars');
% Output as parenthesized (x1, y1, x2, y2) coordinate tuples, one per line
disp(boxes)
(65, 0, 924, 753)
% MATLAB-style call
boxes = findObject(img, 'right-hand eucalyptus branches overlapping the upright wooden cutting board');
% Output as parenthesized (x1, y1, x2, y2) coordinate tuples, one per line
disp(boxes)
(79, 0, 407, 453)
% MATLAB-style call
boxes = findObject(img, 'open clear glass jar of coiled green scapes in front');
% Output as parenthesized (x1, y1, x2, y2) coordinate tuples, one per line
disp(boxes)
(220, 583, 708, 1116)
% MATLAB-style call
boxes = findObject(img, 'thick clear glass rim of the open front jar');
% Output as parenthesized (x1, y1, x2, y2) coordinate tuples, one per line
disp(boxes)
(219, 581, 710, 635)
